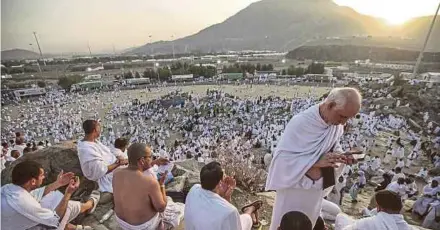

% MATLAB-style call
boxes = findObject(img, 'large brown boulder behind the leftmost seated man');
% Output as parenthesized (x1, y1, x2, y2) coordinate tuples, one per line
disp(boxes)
(1, 145, 97, 196)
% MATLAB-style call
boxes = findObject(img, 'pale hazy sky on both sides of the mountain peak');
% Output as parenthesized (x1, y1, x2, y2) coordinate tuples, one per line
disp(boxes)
(1, 0, 440, 53)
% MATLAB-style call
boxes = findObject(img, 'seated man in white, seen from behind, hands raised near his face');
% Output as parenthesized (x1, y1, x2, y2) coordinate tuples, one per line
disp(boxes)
(185, 162, 262, 230)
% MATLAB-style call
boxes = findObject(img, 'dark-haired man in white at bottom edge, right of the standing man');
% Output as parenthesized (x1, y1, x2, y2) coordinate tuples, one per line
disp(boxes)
(335, 190, 413, 230)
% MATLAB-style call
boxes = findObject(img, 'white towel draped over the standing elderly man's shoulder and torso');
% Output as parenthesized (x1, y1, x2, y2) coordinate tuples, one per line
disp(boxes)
(266, 105, 344, 190)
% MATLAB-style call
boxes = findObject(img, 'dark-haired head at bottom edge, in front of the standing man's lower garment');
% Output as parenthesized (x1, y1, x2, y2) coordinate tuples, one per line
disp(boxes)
(278, 211, 312, 230)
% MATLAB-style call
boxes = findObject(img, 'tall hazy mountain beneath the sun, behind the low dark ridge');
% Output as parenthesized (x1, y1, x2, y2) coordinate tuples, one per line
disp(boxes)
(127, 0, 440, 54)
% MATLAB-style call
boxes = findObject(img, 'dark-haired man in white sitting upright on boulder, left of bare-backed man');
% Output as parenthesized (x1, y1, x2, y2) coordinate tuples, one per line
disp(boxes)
(78, 120, 127, 193)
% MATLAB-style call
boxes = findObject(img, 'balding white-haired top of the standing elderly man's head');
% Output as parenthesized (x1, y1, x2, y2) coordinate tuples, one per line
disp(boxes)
(325, 88, 362, 108)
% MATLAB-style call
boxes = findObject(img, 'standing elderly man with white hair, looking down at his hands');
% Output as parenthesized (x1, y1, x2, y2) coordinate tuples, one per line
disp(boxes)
(266, 88, 362, 230)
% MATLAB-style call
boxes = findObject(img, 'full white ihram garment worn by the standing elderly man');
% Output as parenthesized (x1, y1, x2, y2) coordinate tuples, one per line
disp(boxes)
(266, 105, 343, 230)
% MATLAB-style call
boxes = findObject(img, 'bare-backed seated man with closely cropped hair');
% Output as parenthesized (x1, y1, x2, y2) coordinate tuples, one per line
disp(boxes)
(113, 143, 184, 230)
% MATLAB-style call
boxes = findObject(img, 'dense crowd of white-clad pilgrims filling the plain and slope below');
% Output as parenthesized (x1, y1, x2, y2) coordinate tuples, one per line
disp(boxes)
(1, 87, 440, 228)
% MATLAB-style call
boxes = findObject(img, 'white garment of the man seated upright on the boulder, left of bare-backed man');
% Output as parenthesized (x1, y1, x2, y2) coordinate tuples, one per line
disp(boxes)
(77, 141, 116, 193)
